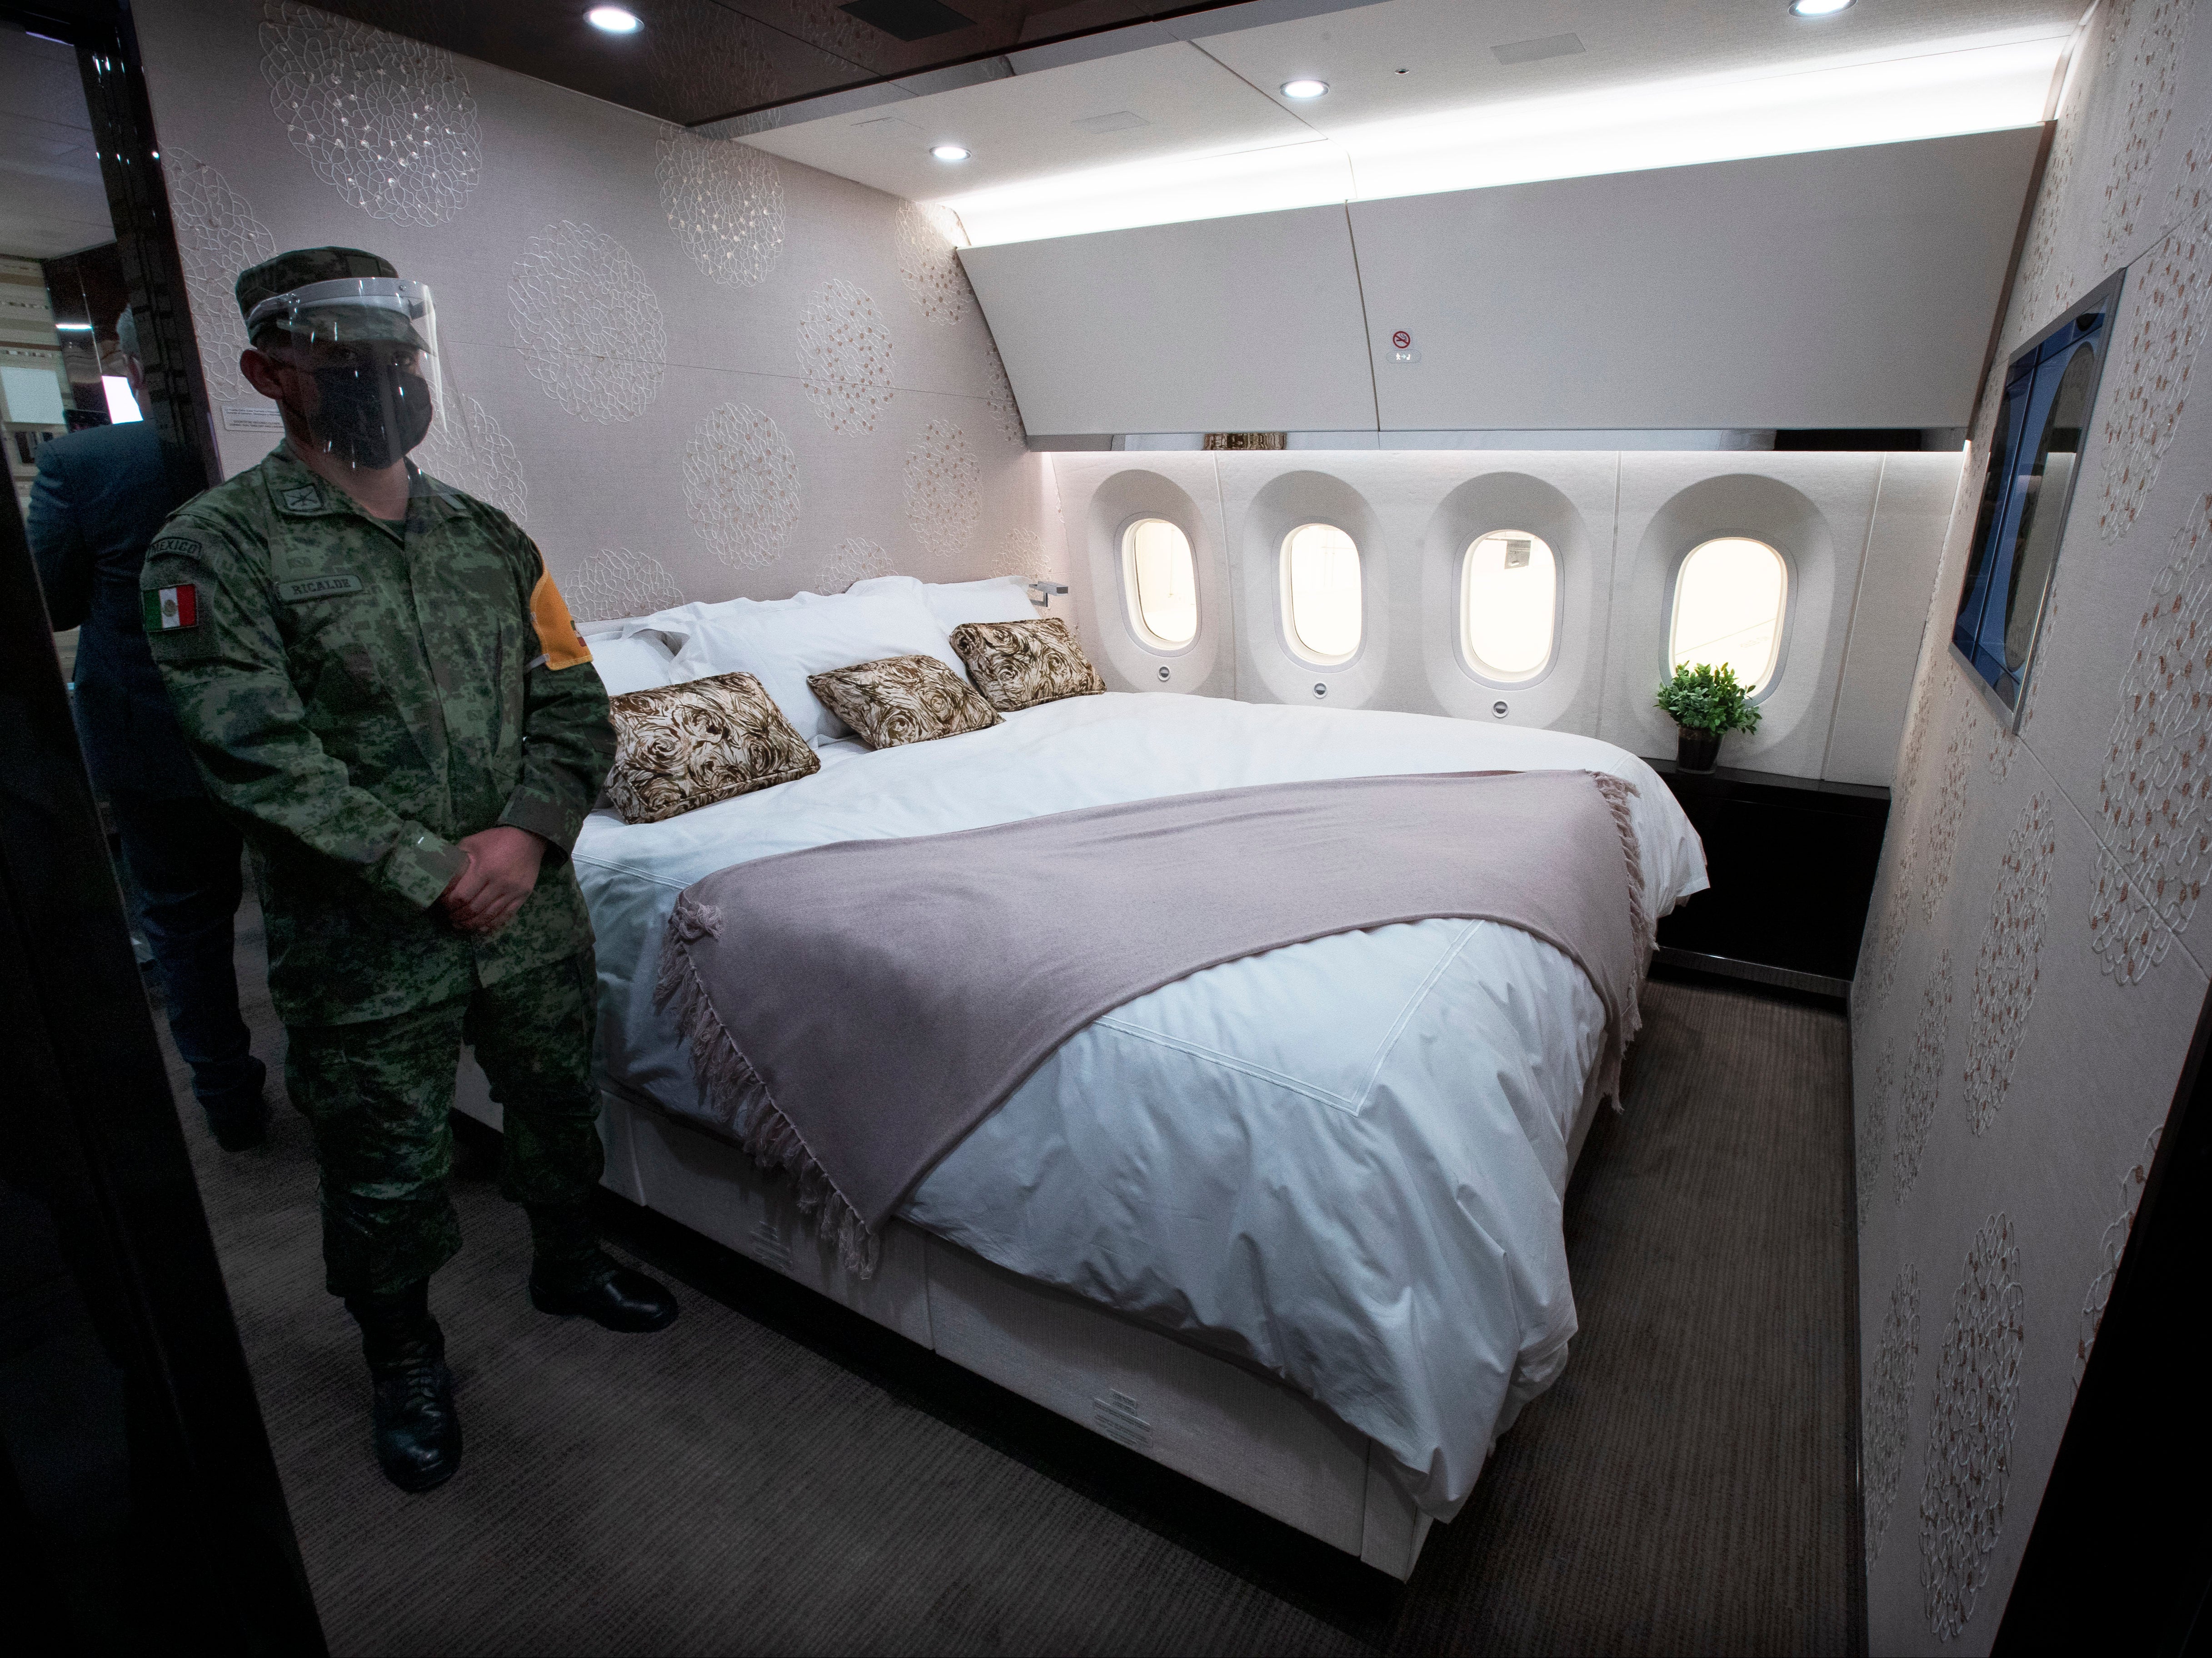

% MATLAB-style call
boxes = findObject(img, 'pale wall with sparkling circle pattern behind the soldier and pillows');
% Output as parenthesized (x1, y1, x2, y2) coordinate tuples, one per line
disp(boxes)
(135, 0, 1066, 619)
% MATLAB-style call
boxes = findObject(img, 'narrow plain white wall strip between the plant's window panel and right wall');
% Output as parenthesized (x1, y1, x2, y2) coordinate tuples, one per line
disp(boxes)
(1821, 453, 1962, 789)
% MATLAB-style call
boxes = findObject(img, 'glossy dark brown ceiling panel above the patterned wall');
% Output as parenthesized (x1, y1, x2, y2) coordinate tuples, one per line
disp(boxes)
(319, 0, 1265, 126)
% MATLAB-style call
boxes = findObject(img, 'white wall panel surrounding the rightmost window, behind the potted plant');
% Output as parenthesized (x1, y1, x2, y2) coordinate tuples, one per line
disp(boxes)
(1597, 453, 1882, 776)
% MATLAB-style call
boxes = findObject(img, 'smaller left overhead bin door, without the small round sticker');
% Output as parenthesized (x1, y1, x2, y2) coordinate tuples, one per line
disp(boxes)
(960, 208, 1376, 433)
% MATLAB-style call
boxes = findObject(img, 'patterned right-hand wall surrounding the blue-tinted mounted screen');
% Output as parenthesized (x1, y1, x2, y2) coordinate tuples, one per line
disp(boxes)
(1852, 0, 2212, 1653)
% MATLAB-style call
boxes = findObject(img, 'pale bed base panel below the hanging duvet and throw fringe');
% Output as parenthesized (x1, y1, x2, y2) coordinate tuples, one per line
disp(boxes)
(456, 1057, 1593, 1583)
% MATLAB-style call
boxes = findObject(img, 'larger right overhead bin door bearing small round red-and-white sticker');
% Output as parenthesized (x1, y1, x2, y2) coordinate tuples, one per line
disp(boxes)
(1345, 128, 2039, 433)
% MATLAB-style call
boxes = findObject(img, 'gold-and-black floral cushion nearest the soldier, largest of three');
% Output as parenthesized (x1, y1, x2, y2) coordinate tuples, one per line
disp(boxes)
(606, 674, 823, 822)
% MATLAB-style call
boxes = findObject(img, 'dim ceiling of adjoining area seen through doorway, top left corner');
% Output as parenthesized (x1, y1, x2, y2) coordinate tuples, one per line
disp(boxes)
(0, 31, 115, 259)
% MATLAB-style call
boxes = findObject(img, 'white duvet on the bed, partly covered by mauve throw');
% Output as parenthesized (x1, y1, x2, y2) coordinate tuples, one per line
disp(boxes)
(575, 694, 1705, 1519)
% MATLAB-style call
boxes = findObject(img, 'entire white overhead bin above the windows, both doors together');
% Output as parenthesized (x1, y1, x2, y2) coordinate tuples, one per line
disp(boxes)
(962, 126, 2042, 433)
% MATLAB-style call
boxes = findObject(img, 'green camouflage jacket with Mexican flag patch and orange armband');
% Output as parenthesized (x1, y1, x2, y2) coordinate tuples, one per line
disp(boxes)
(140, 444, 615, 1026)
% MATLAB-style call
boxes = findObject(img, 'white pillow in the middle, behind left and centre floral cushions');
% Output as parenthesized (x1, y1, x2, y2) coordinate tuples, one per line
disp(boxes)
(672, 588, 967, 745)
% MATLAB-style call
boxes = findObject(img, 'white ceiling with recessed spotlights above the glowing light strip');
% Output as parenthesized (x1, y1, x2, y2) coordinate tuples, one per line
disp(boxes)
(748, 0, 2086, 222)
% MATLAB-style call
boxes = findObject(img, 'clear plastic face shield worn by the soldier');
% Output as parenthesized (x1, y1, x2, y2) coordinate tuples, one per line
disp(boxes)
(245, 276, 442, 468)
